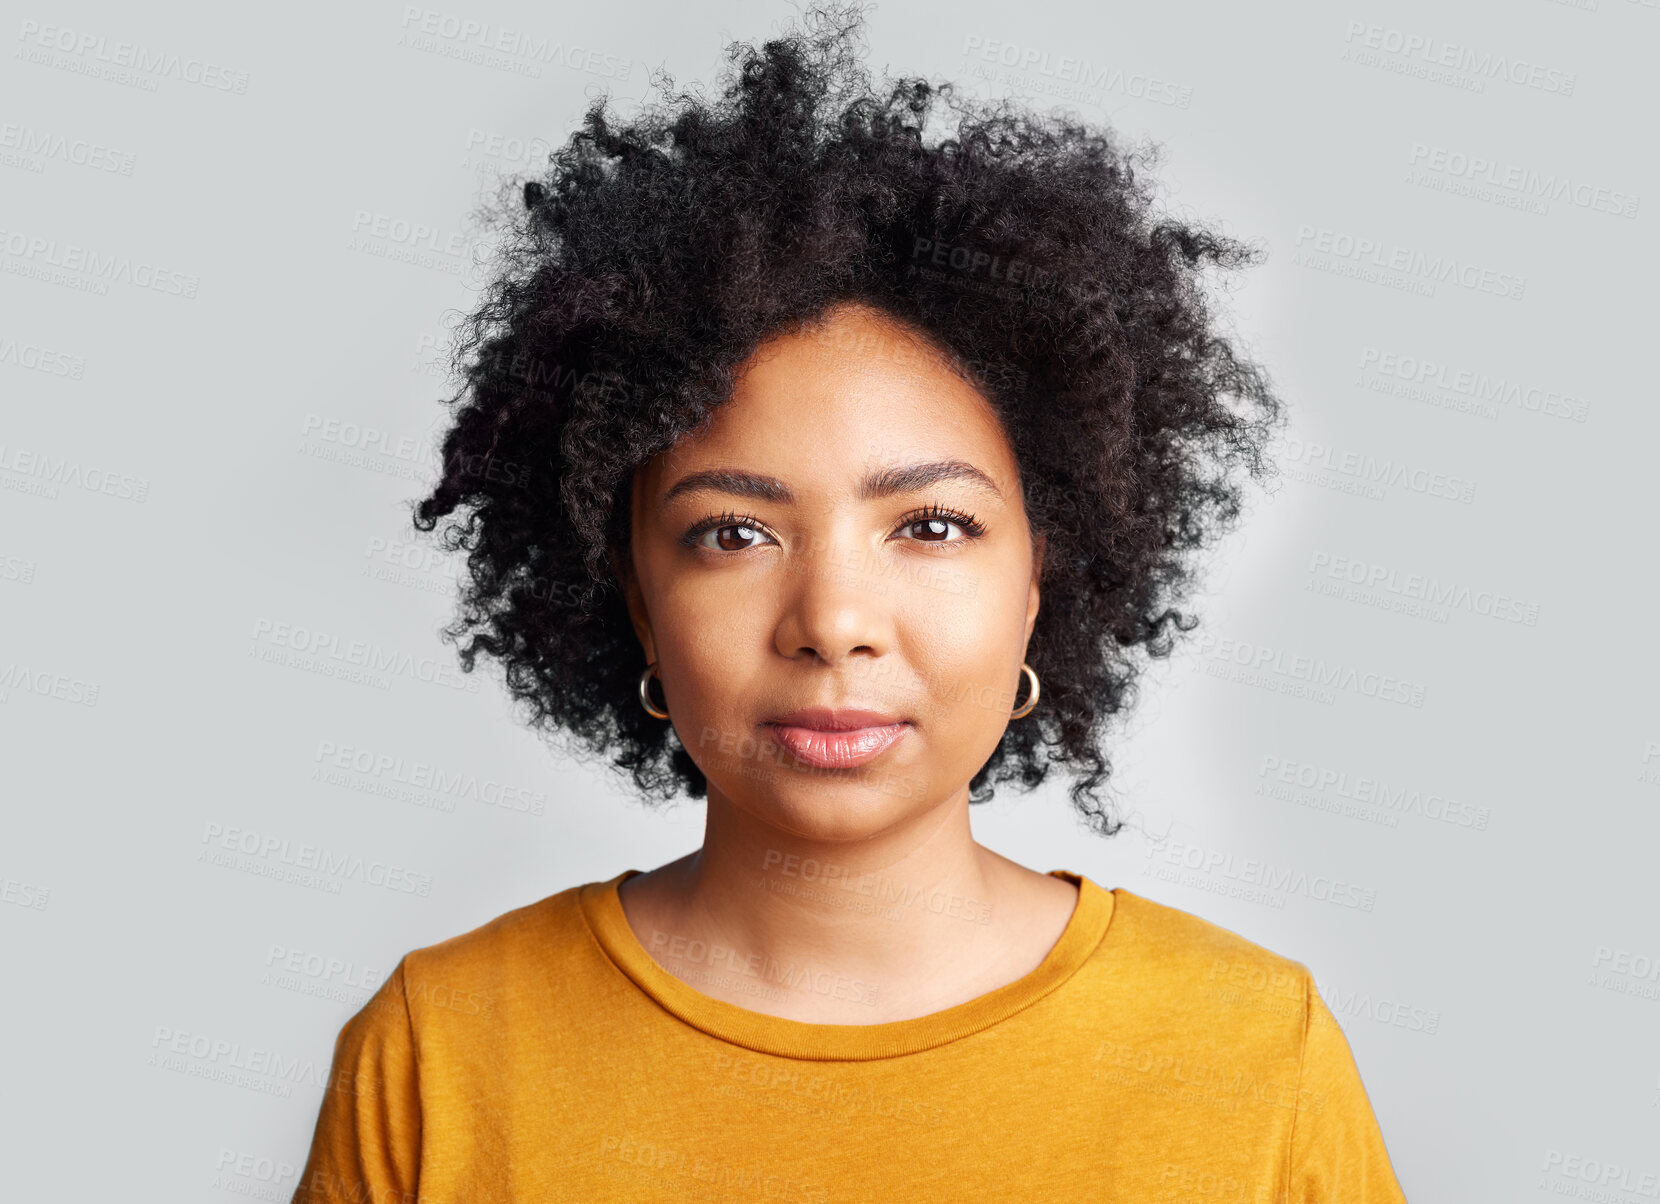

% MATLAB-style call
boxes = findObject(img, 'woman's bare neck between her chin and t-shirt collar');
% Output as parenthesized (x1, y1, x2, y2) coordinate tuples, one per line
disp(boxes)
(623, 773, 1069, 1023)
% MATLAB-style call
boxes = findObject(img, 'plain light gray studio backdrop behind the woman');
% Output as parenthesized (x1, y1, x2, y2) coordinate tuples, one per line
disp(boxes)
(0, 0, 1660, 1204)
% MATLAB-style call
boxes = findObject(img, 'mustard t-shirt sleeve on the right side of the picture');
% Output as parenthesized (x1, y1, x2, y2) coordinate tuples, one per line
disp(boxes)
(1290, 976, 1406, 1204)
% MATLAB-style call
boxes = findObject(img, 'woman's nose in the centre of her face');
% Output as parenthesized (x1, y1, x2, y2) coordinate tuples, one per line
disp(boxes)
(774, 548, 893, 666)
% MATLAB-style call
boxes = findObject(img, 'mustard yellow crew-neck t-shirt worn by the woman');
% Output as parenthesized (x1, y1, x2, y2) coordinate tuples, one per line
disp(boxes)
(294, 870, 1403, 1204)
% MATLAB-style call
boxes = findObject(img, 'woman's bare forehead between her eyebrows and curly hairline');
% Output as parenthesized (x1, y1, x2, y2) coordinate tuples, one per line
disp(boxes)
(642, 306, 1019, 497)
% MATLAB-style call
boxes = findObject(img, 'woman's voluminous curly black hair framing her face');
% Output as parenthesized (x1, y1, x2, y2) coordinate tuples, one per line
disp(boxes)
(413, 3, 1283, 835)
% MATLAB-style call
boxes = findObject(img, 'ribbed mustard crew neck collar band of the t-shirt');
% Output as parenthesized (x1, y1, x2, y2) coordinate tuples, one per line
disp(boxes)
(578, 870, 1116, 1061)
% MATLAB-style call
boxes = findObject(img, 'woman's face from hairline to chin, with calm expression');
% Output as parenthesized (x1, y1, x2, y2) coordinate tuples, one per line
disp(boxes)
(626, 306, 1042, 840)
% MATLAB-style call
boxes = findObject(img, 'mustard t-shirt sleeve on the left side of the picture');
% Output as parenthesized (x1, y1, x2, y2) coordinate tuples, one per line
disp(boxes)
(291, 960, 422, 1204)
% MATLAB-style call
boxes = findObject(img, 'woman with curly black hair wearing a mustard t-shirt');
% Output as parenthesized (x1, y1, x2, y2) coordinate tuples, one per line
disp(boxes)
(295, 8, 1401, 1204)
